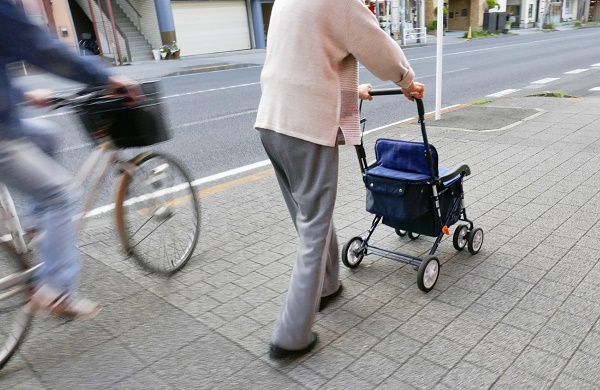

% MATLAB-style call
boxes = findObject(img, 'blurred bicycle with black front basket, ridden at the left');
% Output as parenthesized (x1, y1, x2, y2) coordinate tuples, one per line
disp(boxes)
(0, 82, 201, 368)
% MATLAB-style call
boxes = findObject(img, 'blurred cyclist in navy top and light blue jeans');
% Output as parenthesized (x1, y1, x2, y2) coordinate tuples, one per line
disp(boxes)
(0, 0, 141, 317)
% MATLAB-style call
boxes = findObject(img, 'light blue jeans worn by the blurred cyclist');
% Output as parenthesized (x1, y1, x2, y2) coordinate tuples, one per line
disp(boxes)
(0, 119, 80, 293)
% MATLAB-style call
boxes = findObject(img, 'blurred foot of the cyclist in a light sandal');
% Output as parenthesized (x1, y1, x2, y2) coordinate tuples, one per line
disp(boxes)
(28, 285, 102, 318)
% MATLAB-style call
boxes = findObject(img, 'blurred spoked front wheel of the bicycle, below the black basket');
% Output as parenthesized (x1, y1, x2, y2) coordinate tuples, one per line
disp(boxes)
(115, 153, 200, 275)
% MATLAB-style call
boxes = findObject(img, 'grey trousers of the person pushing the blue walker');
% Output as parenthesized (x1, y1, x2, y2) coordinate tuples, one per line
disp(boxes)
(260, 129, 339, 350)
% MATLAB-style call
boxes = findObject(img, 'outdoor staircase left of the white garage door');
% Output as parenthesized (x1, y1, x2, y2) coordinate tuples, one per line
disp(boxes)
(110, 0, 154, 62)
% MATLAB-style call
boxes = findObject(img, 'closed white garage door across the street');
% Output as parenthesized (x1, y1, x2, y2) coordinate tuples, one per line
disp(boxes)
(171, 0, 250, 56)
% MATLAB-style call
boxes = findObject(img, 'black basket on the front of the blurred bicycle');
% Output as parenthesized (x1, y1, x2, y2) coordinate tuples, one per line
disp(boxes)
(78, 81, 169, 148)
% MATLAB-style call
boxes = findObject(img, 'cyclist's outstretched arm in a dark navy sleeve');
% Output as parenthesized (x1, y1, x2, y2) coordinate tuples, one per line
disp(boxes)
(0, 1, 109, 85)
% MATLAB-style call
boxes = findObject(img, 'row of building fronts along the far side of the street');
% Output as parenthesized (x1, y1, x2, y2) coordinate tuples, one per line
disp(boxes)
(15, 0, 600, 64)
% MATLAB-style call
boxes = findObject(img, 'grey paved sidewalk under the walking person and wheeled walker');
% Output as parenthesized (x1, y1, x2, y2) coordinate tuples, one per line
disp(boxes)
(0, 92, 600, 390)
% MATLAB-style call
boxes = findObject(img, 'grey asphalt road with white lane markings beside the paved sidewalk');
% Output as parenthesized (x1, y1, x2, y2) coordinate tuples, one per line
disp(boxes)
(16, 28, 600, 210)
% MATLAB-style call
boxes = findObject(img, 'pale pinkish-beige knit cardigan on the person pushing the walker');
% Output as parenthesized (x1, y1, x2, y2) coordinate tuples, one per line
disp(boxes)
(254, 0, 414, 146)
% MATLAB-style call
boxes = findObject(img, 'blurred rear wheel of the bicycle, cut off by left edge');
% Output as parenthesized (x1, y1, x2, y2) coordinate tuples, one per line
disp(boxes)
(0, 243, 33, 369)
